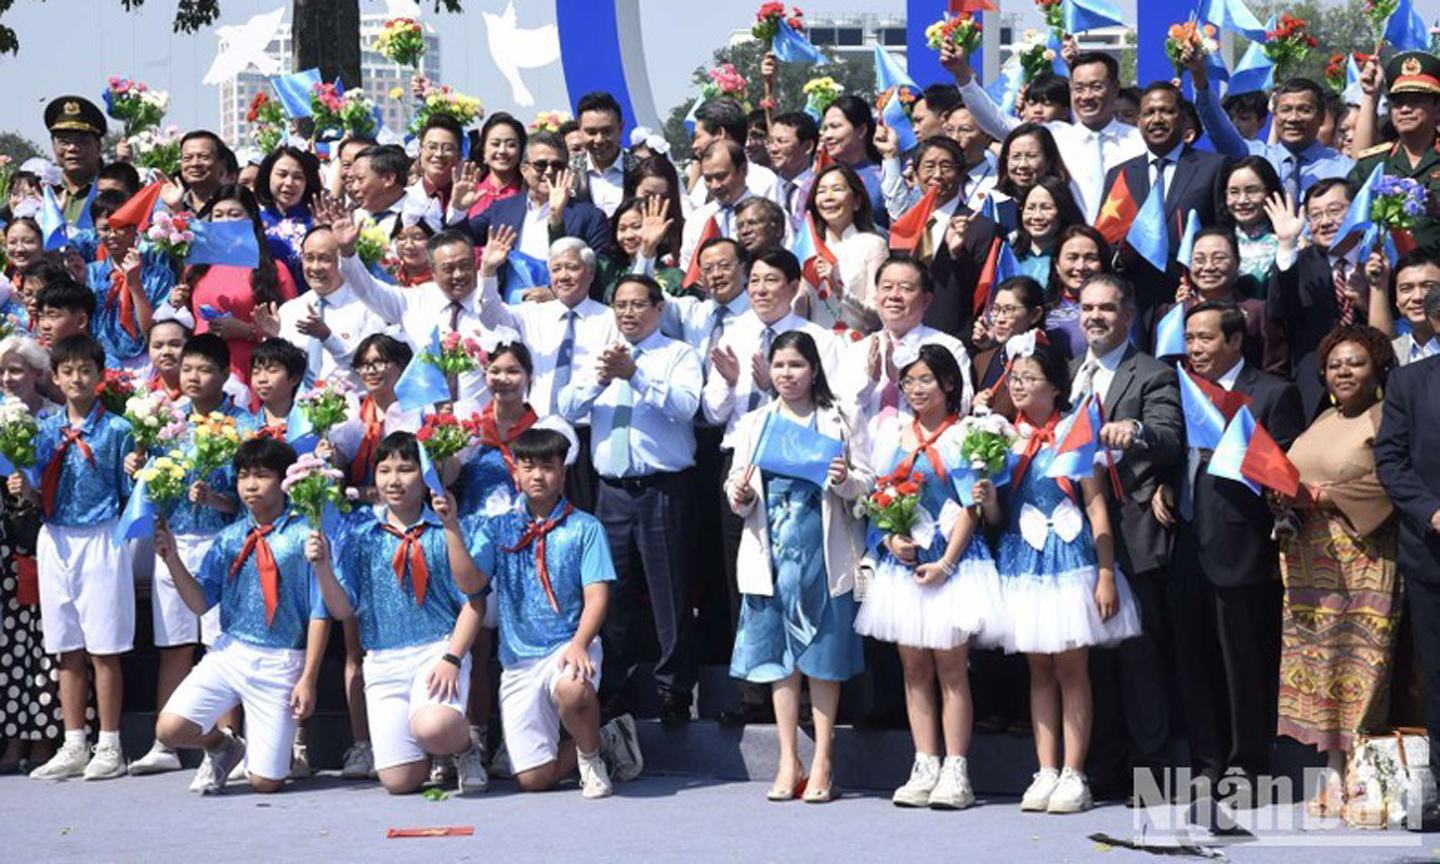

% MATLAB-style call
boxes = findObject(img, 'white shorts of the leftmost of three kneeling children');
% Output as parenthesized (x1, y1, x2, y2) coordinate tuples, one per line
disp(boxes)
(164, 635, 305, 780)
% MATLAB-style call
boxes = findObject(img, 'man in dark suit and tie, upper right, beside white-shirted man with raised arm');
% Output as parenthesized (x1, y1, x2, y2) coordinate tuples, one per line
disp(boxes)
(1104, 81, 1227, 312)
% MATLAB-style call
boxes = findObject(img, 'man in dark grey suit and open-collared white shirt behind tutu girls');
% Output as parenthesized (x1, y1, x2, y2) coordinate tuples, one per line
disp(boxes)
(1070, 275, 1185, 796)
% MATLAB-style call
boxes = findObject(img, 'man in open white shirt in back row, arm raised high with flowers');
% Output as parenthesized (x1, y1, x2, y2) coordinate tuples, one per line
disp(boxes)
(940, 43, 1145, 223)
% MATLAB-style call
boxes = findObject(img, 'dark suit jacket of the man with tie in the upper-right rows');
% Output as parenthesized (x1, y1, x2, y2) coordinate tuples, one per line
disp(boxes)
(1102, 144, 1230, 311)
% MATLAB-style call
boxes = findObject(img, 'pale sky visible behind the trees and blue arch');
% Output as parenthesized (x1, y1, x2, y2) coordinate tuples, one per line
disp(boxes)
(0, 0, 1440, 141)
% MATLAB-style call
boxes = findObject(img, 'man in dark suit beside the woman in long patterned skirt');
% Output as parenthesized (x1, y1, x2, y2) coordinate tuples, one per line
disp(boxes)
(1156, 301, 1305, 802)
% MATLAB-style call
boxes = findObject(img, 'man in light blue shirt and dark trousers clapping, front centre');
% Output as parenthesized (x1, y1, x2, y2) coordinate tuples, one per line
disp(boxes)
(560, 275, 701, 723)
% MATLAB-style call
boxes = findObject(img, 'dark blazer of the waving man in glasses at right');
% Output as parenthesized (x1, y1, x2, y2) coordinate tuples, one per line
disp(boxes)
(1266, 246, 1341, 420)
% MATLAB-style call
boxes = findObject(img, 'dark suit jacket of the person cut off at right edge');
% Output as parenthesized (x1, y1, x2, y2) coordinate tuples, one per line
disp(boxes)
(1375, 357, 1440, 584)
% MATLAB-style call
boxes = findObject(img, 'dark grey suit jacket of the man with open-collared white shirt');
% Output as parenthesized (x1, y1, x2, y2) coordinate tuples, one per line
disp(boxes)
(1070, 346, 1185, 573)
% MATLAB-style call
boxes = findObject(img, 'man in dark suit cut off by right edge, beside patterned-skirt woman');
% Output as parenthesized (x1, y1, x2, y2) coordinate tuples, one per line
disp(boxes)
(1375, 332, 1440, 825)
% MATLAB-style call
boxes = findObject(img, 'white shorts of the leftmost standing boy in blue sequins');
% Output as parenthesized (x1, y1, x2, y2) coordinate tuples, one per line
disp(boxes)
(35, 518, 135, 655)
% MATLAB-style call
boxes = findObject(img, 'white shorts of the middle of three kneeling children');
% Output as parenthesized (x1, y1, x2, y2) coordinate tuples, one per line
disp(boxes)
(364, 639, 469, 770)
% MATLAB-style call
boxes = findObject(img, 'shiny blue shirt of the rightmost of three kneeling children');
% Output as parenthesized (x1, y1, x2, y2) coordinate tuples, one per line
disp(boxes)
(471, 498, 615, 665)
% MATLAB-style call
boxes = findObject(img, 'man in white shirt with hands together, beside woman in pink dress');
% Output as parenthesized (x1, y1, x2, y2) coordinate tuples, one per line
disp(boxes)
(264, 226, 384, 386)
